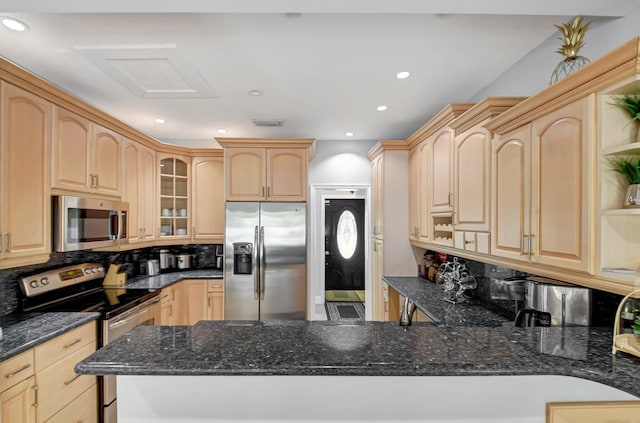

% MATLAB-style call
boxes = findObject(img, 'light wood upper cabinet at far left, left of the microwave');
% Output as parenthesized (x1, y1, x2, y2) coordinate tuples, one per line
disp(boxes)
(0, 82, 52, 268)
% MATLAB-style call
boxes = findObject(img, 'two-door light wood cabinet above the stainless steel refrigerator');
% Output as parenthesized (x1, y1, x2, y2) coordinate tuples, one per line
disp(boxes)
(217, 138, 313, 201)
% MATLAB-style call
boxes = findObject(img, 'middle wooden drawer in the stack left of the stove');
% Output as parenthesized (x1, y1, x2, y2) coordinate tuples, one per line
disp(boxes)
(36, 344, 96, 422)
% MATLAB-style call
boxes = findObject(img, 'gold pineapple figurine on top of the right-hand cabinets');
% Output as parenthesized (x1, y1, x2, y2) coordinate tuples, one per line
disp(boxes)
(549, 16, 591, 85)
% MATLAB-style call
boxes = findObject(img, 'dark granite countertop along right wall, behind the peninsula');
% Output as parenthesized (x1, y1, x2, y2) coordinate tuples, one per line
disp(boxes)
(383, 276, 509, 327)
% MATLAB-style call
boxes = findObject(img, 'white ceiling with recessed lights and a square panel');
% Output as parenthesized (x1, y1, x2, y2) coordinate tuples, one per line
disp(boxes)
(0, 0, 640, 146)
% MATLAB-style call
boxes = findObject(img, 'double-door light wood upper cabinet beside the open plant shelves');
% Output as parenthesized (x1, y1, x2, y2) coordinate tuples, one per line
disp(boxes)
(491, 97, 593, 271)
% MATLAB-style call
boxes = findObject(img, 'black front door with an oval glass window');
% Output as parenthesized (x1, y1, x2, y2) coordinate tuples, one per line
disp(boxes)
(324, 198, 364, 290)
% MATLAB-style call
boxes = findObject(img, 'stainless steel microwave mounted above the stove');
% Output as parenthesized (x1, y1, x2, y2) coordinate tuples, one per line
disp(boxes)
(52, 195, 129, 252)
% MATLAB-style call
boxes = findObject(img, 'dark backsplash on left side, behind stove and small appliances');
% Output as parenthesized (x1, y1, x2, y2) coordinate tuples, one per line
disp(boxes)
(0, 244, 219, 316)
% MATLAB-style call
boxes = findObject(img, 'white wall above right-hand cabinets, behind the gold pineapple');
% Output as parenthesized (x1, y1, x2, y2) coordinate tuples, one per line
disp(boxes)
(469, 9, 640, 101)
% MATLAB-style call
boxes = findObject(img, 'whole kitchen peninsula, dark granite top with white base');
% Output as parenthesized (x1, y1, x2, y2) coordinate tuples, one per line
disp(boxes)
(76, 308, 640, 422)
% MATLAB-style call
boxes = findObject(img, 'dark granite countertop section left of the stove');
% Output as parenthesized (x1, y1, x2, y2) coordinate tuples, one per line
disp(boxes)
(0, 313, 100, 361)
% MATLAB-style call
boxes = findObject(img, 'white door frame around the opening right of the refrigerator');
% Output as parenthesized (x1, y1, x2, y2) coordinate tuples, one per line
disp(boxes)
(307, 184, 372, 320)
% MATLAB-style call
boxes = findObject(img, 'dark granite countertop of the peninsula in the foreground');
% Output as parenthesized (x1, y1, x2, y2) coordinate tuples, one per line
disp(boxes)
(76, 321, 640, 397)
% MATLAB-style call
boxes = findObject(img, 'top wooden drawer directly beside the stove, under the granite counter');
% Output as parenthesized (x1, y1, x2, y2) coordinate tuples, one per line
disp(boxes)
(35, 322, 96, 372)
